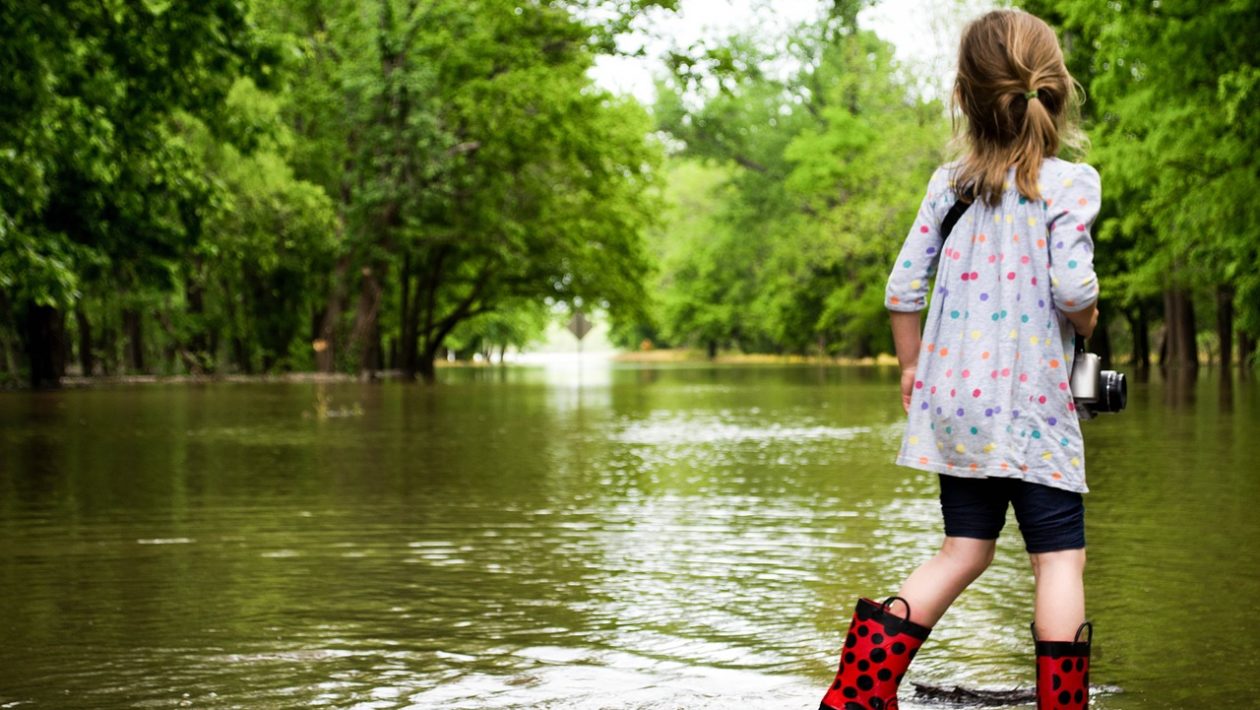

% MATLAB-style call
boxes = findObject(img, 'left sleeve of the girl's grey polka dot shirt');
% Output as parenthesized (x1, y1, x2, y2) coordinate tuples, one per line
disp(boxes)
(883, 166, 954, 311)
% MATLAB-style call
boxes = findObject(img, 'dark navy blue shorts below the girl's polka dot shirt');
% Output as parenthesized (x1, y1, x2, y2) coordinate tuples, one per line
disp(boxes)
(939, 473, 1085, 552)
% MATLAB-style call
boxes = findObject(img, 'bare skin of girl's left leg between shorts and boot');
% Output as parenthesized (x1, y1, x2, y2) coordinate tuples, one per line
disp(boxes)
(897, 537, 992, 631)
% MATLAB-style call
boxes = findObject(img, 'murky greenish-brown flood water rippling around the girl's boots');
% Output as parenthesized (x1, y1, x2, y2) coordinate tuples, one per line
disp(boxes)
(0, 363, 1260, 710)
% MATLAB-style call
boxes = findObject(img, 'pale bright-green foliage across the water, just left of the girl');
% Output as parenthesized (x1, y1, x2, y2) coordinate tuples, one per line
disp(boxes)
(656, 18, 945, 354)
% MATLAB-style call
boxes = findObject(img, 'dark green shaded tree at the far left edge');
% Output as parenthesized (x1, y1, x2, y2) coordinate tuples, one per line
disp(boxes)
(0, 0, 270, 386)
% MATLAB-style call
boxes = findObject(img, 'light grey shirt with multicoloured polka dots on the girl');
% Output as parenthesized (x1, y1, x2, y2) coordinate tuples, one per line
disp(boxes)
(885, 158, 1101, 493)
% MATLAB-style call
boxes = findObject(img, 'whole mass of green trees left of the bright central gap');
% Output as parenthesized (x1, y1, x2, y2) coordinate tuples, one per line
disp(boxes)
(0, 0, 675, 383)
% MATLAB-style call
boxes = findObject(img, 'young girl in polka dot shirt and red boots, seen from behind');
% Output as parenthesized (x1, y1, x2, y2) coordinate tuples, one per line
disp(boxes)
(822, 10, 1100, 710)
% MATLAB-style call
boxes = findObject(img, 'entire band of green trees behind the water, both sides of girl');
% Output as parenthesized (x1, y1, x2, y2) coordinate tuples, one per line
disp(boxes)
(0, 0, 1260, 386)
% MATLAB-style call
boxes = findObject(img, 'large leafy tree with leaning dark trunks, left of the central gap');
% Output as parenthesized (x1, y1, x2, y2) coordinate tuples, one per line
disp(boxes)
(260, 0, 656, 382)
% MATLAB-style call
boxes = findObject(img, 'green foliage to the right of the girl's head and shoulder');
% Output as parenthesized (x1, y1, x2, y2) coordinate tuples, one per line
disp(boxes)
(1023, 0, 1260, 365)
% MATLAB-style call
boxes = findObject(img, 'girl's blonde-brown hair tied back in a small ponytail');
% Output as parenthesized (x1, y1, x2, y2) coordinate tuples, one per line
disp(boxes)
(953, 10, 1085, 206)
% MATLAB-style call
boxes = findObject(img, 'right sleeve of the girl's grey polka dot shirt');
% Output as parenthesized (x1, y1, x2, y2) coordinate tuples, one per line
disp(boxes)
(1046, 164, 1103, 313)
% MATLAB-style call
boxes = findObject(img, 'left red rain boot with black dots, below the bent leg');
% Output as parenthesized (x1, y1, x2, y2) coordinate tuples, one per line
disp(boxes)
(819, 597, 932, 710)
